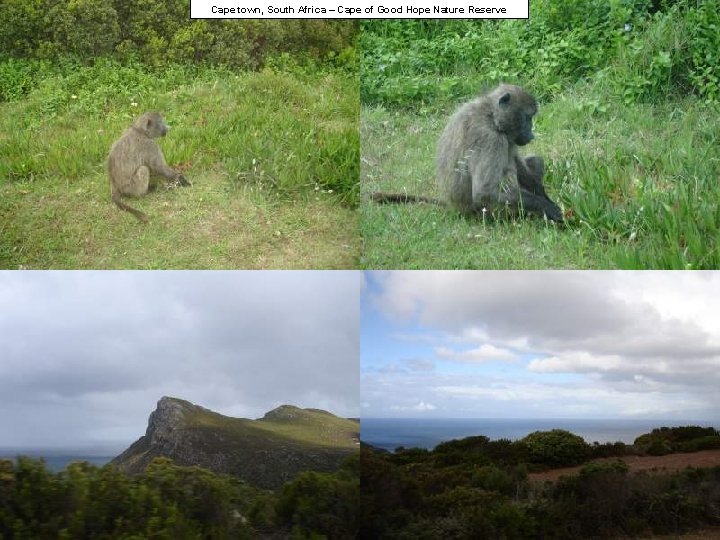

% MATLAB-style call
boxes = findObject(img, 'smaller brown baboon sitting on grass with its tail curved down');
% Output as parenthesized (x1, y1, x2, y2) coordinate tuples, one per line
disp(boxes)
(107, 112, 191, 223)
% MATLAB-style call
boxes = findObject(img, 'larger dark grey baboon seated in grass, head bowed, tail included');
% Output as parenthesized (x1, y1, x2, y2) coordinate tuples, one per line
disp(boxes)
(371, 84, 563, 221)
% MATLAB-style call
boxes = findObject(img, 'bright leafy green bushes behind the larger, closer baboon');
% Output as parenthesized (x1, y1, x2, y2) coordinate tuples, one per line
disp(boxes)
(361, 0, 720, 106)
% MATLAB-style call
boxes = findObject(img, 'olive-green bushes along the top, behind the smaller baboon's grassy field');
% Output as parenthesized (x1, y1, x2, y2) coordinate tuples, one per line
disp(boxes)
(0, 0, 357, 70)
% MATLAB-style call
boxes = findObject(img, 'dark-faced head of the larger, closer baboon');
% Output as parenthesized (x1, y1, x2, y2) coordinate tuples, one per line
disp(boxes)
(490, 84, 537, 146)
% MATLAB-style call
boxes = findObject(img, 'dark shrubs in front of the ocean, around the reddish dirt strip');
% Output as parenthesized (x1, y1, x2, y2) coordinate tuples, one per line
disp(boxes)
(359, 427, 720, 540)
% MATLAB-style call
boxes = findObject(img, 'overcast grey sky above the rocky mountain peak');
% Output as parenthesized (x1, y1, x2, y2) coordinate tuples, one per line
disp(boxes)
(0, 271, 362, 452)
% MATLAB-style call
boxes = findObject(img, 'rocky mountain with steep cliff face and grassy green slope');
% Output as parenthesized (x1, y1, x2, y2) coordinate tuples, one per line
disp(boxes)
(111, 397, 360, 489)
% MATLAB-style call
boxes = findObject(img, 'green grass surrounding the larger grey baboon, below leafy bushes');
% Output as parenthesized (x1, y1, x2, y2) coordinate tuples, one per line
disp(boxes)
(360, 83, 720, 269)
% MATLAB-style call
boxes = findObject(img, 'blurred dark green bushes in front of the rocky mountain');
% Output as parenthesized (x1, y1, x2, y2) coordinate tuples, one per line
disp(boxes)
(0, 457, 359, 540)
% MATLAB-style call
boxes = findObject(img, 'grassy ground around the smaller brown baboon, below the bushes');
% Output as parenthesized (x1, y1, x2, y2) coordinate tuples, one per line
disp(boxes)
(0, 63, 359, 269)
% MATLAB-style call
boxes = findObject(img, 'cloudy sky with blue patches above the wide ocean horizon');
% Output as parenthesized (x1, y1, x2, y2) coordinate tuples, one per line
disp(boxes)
(360, 271, 720, 424)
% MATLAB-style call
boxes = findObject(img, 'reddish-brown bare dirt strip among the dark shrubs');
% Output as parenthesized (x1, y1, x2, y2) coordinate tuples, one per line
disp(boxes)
(528, 450, 720, 484)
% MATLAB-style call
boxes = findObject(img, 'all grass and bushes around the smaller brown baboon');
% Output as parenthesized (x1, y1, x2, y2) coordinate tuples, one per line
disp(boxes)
(0, 8, 359, 269)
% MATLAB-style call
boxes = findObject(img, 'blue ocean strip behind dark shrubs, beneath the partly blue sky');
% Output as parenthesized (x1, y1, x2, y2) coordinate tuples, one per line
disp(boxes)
(360, 418, 710, 451)
